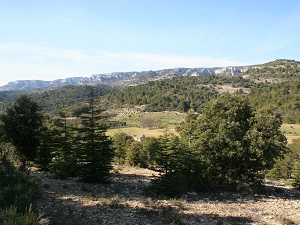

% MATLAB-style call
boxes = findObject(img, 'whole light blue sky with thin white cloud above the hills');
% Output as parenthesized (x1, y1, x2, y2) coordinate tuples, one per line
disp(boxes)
(0, 0, 300, 86)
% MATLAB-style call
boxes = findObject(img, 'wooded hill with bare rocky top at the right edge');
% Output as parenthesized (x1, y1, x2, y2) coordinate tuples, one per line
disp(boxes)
(243, 60, 300, 123)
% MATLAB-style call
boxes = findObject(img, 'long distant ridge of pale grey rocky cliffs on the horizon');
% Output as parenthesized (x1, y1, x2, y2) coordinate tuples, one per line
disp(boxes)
(0, 66, 253, 91)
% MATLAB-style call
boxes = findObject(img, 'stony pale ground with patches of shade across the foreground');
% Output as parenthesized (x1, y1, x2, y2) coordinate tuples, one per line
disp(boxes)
(32, 167, 300, 225)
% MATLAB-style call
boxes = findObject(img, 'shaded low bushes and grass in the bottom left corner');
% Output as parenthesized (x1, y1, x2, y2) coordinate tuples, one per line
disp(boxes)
(0, 143, 42, 225)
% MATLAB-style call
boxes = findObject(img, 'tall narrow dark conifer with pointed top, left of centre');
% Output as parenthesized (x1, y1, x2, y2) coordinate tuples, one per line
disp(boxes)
(77, 92, 113, 183)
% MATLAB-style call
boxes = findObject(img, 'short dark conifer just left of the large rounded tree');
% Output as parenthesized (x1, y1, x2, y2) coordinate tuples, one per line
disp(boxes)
(153, 134, 199, 195)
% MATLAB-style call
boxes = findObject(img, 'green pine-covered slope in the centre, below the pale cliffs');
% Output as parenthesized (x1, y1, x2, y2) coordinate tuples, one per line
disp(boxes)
(102, 76, 254, 112)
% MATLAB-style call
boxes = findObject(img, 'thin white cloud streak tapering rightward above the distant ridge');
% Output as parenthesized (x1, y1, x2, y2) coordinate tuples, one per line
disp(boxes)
(0, 42, 245, 68)
